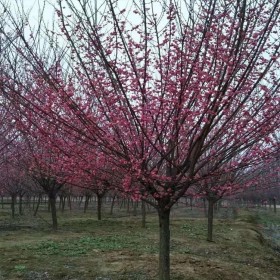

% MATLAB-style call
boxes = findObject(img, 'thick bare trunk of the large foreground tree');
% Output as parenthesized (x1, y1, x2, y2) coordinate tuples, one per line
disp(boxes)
(158, 209, 170, 280)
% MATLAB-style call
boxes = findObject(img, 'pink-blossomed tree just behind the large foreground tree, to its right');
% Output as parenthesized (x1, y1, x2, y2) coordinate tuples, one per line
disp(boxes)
(191, 134, 279, 241)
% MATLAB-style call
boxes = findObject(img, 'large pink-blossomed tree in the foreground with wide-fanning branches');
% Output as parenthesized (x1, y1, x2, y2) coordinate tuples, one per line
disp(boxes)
(1, 0, 280, 280)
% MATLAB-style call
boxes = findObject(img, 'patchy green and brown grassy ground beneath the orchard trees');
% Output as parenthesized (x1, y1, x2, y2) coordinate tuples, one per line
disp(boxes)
(0, 202, 280, 280)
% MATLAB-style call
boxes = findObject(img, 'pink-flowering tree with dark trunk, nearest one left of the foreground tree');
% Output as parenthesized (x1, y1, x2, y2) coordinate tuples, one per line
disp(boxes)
(14, 111, 70, 230)
